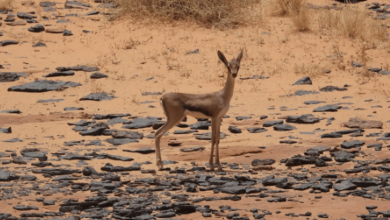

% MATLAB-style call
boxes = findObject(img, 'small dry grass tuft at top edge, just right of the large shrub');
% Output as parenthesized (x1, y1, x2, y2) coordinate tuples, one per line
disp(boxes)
(270, 0, 304, 16)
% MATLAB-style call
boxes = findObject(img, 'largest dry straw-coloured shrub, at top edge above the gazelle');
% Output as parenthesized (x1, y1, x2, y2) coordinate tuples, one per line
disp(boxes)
(114, 0, 261, 28)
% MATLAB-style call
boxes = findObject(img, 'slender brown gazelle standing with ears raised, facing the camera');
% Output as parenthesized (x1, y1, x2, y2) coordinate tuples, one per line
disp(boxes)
(155, 50, 243, 170)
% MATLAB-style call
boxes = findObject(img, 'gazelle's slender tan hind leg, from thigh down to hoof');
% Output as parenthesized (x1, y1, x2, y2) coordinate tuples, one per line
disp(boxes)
(154, 103, 185, 169)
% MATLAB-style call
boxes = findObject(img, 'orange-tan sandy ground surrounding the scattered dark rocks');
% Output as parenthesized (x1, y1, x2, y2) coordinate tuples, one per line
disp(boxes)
(0, 0, 390, 219)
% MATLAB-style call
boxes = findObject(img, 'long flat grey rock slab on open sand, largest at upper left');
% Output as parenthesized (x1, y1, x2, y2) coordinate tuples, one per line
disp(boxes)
(8, 80, 81, 92)
